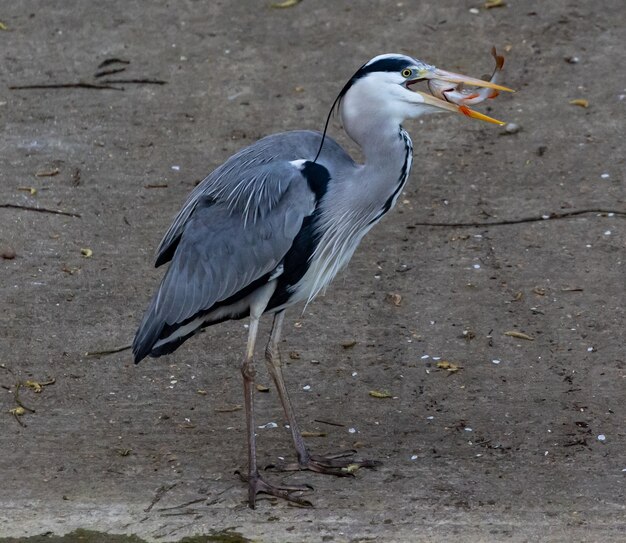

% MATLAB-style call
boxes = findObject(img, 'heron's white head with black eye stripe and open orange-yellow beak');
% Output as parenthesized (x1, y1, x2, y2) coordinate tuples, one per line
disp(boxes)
(338, 54, 511, 131)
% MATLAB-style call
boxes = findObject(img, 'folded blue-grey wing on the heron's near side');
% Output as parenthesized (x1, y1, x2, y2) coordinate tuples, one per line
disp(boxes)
(133, 161, 315, 361)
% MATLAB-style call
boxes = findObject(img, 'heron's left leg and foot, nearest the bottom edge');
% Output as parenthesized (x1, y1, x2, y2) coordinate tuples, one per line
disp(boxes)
(240, 292, 311, 509)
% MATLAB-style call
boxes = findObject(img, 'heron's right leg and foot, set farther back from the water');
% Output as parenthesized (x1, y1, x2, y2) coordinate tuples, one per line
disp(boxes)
(265, 311, 380, 477)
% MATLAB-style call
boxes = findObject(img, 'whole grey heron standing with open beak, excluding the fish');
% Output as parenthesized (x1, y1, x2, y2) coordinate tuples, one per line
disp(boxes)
(133, 54, 510, 508)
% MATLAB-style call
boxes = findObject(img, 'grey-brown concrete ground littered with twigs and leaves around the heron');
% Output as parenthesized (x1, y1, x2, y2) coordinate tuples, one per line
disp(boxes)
(0, 0, 626, 543)
